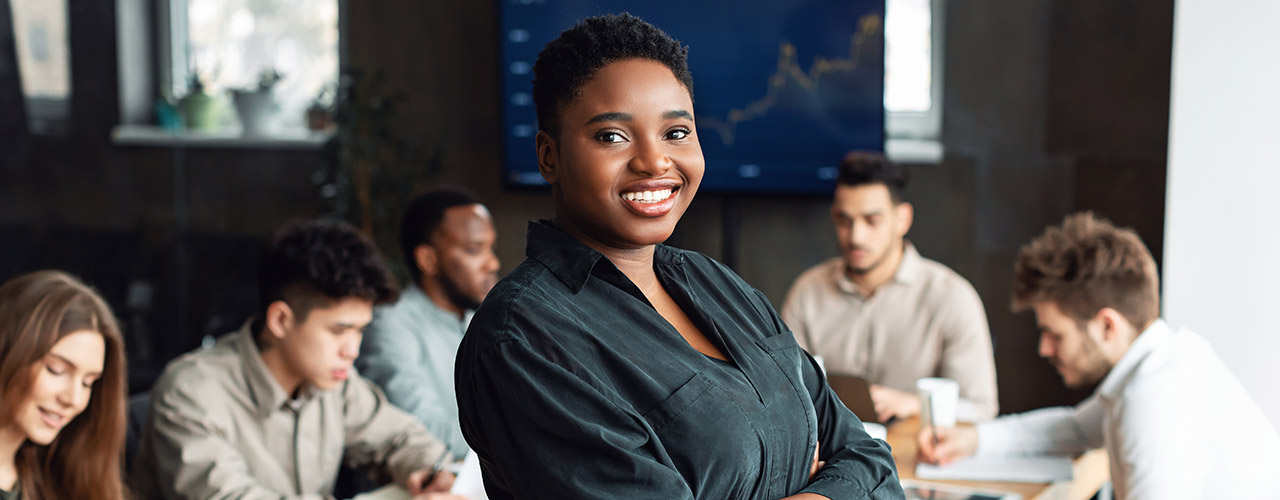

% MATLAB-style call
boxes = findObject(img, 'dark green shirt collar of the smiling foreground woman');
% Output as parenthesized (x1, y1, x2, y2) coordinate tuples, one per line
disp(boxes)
(525, 219, 685, 293)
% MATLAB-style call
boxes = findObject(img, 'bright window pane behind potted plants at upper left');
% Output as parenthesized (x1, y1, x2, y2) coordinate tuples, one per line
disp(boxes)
(160, 0, 338, 128)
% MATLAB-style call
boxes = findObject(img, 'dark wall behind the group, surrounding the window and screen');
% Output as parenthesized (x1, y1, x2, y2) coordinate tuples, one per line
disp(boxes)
(0, 0, 1172, 412)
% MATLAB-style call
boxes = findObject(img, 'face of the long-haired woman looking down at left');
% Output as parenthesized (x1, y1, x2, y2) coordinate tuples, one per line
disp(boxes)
(14, 330, 106, 445)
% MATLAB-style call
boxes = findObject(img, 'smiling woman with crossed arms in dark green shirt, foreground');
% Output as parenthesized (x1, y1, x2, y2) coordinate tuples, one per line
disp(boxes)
(456, 14, 902, 500)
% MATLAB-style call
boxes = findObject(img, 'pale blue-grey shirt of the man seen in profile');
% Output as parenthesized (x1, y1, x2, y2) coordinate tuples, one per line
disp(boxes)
(356, 284, 472, 459)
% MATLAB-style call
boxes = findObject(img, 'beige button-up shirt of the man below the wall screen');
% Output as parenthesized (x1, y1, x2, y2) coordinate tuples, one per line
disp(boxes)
(782, 242, 1000, 421)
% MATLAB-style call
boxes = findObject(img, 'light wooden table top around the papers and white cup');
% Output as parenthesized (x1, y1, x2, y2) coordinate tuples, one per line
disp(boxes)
(886, 417, 1110, 500)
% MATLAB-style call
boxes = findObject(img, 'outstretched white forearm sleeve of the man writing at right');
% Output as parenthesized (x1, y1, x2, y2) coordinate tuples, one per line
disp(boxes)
(974, 395, 1106, 457)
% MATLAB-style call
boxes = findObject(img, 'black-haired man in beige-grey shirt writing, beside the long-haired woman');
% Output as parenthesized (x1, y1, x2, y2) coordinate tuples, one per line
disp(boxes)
(132, 221, 454, 500)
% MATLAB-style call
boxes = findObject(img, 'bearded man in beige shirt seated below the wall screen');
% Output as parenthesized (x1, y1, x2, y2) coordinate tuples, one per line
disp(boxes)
(782, 152, 997, 422)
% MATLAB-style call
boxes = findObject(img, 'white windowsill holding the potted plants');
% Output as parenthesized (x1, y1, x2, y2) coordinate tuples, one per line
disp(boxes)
(111, 125, 333, 150)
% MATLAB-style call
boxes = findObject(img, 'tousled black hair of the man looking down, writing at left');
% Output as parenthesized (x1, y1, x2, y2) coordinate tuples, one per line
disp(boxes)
(257, 219, 399, 321)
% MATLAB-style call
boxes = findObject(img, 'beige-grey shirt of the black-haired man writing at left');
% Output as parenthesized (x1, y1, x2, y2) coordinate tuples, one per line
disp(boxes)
(133, 324, 444, 500)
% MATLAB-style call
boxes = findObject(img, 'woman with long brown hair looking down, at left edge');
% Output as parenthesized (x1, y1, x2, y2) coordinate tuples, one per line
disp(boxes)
(0, 271, 124, 500)
